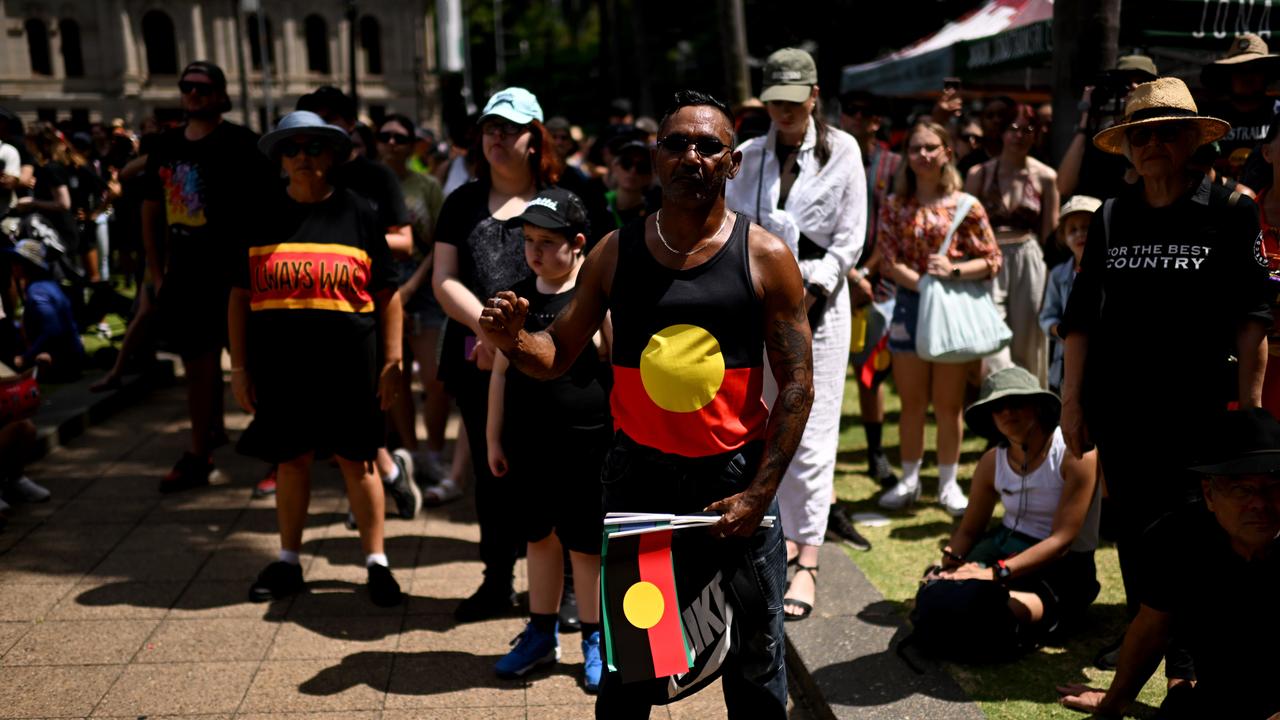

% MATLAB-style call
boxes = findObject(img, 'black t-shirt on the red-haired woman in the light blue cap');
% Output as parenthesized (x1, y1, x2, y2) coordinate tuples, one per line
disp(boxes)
(435, 181, 534, 302)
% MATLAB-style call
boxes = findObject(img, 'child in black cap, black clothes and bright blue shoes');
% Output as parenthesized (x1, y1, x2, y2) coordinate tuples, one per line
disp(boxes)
(486, 188, 612, 693)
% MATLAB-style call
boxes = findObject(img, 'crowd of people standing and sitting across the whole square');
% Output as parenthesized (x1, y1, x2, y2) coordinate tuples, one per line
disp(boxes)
(0, 35, 1280, 720)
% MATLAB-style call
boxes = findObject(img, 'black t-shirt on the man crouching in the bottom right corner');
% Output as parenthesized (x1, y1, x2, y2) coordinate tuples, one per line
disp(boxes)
(1142, 505, 1280, 720)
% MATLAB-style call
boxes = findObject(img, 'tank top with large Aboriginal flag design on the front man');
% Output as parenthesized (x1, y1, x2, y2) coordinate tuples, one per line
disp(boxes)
(609, 215, 768, 457)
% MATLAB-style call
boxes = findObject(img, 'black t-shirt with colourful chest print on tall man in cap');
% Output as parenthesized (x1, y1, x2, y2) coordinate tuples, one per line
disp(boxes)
(143, 122, 271, 280)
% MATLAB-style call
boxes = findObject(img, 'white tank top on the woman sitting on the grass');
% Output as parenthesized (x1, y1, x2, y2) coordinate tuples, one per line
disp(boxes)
(996, 428, 1102, 552)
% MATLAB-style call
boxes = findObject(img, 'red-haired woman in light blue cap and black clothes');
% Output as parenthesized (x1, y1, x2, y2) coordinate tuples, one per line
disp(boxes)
(431, 87, 559, 621)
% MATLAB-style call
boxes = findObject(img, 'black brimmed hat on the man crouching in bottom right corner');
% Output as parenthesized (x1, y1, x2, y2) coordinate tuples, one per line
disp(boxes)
(1190, 407, 1280, 475)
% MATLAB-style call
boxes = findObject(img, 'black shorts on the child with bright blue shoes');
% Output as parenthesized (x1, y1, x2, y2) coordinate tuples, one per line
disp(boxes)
(497, 428, 613, 555)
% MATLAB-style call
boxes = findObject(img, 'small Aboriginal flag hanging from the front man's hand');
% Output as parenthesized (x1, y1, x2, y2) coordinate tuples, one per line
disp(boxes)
(600, 528, 691, 683)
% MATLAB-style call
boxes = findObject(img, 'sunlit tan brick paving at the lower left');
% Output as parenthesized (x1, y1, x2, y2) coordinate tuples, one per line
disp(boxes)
(0, 388, 808, 720)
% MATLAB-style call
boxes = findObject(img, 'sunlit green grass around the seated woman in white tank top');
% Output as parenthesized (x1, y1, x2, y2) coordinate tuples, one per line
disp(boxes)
(836, 371, 1165, 720)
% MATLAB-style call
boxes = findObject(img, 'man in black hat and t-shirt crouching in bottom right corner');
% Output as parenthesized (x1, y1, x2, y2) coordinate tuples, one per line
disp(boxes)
(1059, 409, 1280, 720)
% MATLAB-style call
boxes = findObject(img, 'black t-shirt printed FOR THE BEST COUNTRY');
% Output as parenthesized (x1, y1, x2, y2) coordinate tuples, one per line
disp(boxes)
(1062, 172, 1274, 448)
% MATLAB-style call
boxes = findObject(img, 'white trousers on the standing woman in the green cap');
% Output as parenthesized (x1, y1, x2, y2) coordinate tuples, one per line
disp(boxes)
(764, 278, 851, 544)
